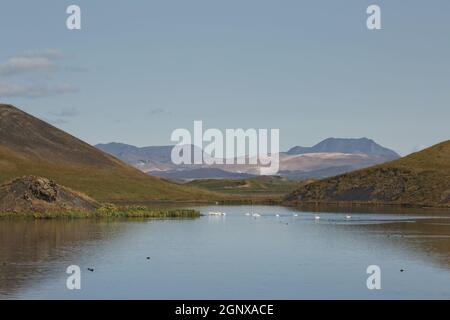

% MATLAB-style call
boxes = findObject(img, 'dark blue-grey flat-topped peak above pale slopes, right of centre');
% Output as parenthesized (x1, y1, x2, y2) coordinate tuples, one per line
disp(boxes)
(287, 137, 400, 160)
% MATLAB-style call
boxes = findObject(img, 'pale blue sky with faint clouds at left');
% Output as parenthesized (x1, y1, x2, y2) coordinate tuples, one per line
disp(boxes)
(0, 0, 450, 155)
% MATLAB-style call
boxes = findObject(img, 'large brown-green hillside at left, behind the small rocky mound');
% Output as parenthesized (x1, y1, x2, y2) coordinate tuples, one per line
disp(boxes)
(0, 104, 222, 202)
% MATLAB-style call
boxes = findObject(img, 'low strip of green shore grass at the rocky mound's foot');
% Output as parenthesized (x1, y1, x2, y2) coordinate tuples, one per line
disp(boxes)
(0, 204, 201, 219)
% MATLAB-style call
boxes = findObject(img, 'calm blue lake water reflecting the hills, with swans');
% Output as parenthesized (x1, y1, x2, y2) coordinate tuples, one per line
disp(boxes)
(0, 206, 450, 299)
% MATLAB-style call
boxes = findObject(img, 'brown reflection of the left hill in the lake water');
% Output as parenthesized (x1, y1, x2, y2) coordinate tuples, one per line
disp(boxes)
(0, 220, 127, 298)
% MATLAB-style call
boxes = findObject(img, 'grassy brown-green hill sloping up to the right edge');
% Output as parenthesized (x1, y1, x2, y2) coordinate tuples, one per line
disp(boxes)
(286, 140, 450, 207)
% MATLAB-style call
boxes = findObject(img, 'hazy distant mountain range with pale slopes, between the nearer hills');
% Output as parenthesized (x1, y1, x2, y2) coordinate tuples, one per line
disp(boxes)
(96, 138, 400, 180)
